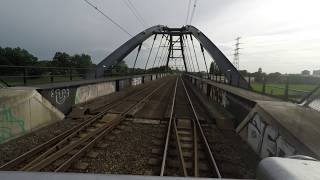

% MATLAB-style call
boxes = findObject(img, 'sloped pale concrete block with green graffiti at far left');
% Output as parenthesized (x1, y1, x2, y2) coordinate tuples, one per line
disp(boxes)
(0, 88, 64, 143)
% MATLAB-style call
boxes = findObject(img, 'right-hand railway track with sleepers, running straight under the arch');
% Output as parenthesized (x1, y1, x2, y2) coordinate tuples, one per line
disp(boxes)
(154, 77, 221, 178)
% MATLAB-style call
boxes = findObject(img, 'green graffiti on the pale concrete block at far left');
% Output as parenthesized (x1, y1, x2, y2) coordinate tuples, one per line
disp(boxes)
(0, 107, 25, 143)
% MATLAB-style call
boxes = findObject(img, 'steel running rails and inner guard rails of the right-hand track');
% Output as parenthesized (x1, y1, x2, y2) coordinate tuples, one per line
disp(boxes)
(160, 76, 221, 178)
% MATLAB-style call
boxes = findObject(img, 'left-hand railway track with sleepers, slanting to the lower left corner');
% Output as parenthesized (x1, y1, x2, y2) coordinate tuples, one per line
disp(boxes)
(0, 77, 172, 172)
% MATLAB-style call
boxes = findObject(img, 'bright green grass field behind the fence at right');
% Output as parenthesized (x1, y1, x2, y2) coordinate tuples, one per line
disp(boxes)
(251, 83, 317, 99)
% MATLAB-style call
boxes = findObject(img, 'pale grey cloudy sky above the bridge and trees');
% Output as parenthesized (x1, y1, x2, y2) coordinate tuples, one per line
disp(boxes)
(0, 0, 320, 73)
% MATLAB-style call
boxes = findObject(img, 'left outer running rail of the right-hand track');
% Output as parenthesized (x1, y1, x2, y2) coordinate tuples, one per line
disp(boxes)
(160, 77, 179, 176)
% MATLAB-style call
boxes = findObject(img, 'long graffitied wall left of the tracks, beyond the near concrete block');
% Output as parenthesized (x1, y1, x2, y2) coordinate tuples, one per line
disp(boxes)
(37, 74, 166, 114)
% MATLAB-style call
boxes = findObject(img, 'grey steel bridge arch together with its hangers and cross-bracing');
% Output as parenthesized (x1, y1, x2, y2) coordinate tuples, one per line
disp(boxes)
(96, 25, 250, 89)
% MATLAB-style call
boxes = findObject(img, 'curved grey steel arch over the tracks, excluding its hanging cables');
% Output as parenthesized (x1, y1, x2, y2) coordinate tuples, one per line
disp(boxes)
(96, 25, 250, 89)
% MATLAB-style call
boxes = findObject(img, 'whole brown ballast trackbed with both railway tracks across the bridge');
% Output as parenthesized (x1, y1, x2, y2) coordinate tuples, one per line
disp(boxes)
(0, 76, 253, 178)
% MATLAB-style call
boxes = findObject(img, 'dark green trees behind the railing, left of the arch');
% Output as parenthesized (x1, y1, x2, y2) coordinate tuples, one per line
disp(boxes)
(0, 47, 95, 75)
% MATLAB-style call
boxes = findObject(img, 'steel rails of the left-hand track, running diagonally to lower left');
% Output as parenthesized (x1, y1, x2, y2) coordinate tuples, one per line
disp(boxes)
(0, 79, 166, 171)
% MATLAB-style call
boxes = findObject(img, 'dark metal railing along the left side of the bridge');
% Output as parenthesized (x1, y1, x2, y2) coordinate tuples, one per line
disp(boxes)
(0, 65, 172, 88)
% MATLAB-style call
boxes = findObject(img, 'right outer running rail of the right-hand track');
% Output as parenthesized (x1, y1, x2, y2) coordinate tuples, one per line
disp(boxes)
(180, 76, 221, 178)
